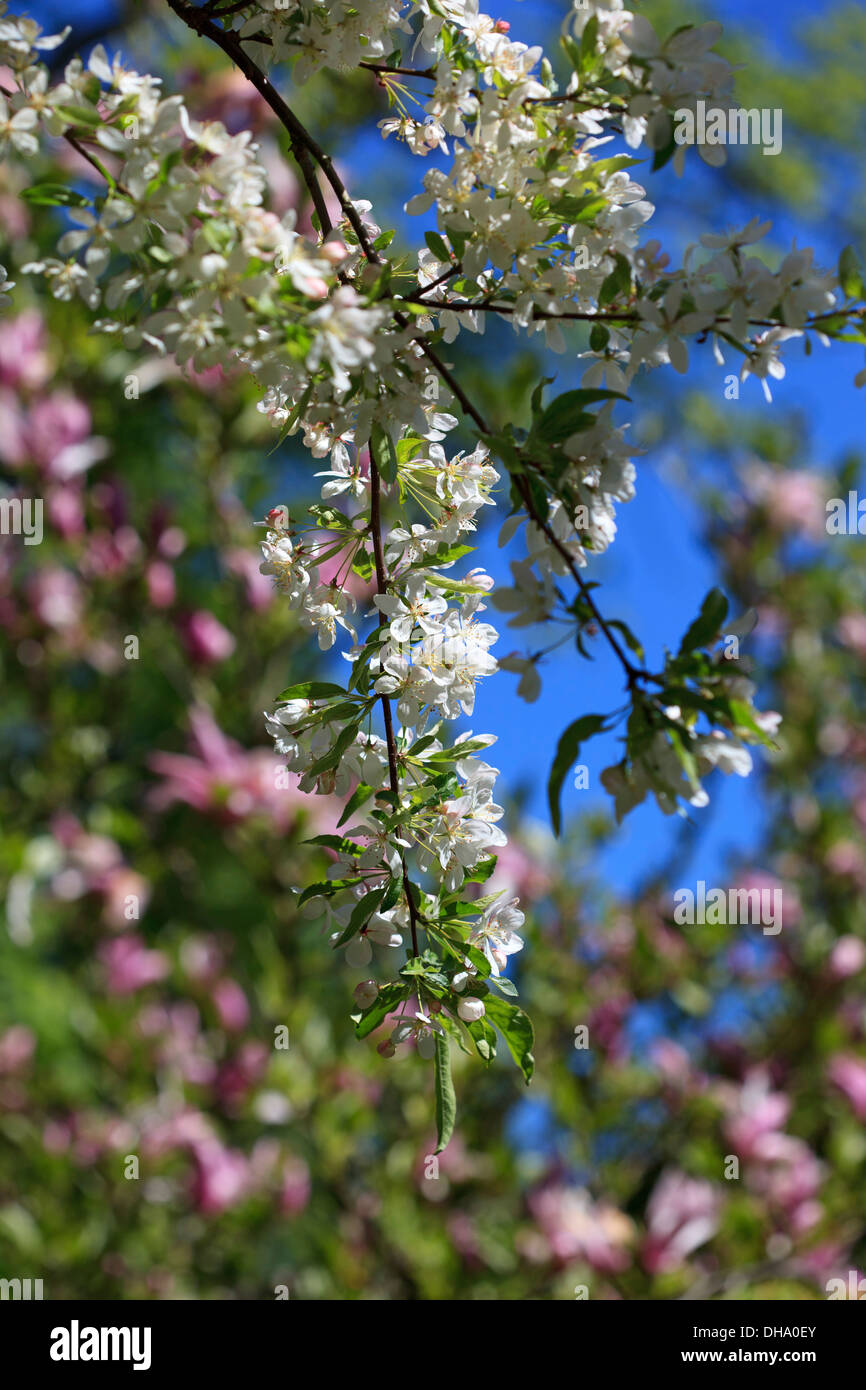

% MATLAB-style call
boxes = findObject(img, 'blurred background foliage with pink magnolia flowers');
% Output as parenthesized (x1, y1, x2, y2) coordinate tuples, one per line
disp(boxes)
(0, 0, 866, 1300)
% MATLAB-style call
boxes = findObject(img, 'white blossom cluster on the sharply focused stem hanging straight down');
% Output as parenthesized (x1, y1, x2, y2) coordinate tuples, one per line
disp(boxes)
(255, 425, 523, 1055)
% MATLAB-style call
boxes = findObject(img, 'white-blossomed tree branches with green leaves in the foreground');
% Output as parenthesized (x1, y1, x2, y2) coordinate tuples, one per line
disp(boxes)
(0, 0, 866, 1148)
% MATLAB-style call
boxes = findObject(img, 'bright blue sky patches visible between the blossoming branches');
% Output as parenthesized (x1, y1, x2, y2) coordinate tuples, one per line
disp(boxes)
(20, 0, 863, 888)
